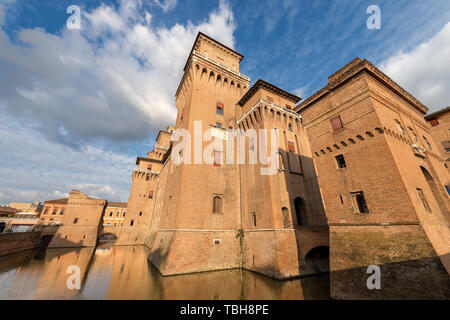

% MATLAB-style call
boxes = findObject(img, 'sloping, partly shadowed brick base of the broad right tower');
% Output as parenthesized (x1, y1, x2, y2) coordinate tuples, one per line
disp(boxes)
(330, 225, 450, 299)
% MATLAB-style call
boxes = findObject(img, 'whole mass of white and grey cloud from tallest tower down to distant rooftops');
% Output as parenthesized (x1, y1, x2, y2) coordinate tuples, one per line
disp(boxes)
(0, 0, 236, 203)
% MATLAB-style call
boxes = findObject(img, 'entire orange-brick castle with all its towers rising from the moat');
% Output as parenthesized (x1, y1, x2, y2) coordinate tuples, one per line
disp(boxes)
(43, 33, 450, 298)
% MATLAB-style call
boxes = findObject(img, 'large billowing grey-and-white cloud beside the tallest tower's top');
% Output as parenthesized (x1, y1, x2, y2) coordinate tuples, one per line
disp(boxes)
(0, 0, 235, 146)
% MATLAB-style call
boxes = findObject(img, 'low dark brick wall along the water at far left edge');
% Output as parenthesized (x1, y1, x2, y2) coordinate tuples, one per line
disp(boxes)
(0, 232, 41, 256)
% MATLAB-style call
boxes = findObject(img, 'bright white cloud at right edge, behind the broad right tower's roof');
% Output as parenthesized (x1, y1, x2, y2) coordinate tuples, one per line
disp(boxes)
(380, 22, 450, 111)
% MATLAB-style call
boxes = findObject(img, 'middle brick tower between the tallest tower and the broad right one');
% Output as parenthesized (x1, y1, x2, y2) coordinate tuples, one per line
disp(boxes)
(236, 80, 329, 279)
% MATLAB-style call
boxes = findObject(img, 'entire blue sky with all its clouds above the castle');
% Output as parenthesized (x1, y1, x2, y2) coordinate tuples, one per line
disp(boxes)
(0, 0, 450, 203)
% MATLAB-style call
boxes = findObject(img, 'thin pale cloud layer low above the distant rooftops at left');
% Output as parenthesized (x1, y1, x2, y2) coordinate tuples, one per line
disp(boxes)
(0, 112, 136, 203)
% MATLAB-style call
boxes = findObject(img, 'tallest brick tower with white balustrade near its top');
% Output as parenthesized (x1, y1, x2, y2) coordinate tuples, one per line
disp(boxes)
(147, 33, 250, 275)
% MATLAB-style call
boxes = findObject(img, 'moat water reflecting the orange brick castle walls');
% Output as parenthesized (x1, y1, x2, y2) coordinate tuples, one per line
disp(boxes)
(0, 246, 330, 300)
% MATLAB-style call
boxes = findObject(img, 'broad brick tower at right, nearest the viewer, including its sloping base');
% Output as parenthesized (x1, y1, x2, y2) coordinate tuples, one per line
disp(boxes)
(297, 58, 450, 299)
